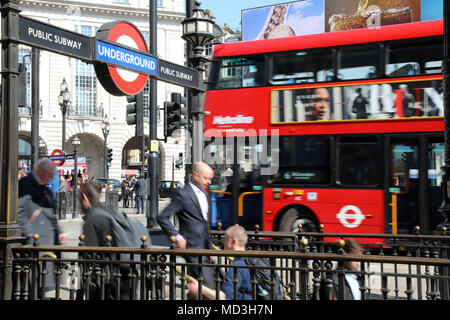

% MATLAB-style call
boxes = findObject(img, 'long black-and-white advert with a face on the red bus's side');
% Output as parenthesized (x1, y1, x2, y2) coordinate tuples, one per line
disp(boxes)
(271, 80, 444, 123)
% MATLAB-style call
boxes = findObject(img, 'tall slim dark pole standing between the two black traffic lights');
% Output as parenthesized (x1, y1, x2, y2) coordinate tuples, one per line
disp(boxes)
(147, 0, 159, 228)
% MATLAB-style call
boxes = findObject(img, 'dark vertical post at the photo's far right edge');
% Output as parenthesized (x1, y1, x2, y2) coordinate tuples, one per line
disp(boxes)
(438, 0, 450, 229)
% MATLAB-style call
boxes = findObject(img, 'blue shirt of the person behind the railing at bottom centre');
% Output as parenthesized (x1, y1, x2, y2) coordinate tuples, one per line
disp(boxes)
(222, 259, 252, 300)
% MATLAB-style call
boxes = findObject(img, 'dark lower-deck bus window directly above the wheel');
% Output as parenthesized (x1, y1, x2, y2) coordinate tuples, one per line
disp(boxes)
(268, 136, 331, 185)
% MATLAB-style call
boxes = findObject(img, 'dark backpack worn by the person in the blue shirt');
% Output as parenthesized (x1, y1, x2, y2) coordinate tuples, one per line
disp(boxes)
(245, 258, 284, 300)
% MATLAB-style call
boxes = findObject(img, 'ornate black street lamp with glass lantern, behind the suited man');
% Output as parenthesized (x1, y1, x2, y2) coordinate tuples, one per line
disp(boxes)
(181, 0, 215, 170)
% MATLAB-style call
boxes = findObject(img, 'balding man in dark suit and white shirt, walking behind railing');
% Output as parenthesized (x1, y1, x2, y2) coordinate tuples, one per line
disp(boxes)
(157, 162, 215, 298)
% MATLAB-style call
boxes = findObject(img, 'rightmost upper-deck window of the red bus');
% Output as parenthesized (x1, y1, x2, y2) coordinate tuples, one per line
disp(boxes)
(386, 37, 443, 77)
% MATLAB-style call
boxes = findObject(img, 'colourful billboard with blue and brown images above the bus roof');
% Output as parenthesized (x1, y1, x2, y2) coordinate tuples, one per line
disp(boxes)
(241, 0, 443, 41)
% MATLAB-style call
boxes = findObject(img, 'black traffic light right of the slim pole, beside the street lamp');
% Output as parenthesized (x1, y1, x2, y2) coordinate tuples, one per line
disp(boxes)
(164, 92, 186, 137)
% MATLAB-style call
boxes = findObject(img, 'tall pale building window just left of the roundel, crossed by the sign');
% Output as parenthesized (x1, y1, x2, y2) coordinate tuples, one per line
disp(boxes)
(73, 26, 96, 116)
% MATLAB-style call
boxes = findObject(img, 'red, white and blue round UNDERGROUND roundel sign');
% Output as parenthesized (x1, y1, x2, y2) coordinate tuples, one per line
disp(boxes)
(95, 21, 158, 96)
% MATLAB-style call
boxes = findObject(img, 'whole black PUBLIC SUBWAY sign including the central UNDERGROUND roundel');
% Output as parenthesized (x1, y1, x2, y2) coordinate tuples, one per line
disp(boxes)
(19, 15, 203, 96)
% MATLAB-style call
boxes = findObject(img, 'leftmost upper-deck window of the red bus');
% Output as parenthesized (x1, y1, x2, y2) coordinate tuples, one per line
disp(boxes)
(213, 56, 264, 89)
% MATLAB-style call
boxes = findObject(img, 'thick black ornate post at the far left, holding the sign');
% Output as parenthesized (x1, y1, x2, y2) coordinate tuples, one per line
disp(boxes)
(0, 0, 23, 300)
